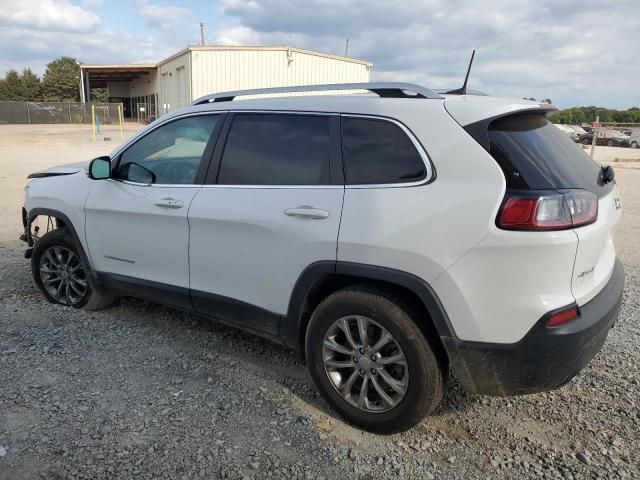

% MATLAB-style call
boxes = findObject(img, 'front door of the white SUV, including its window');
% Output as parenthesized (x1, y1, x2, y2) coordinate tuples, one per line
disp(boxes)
(86, 115, 222, 307)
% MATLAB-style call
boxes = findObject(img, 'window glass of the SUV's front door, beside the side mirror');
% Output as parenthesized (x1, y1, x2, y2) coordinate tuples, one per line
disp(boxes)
(115, 115, 220, 185)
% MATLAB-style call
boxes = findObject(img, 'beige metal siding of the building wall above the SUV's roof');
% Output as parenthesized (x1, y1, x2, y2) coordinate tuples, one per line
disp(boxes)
(191, 48, 370, 100)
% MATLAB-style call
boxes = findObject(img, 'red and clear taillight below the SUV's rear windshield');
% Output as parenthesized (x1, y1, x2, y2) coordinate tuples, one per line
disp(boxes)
(497, 191, 598, 231)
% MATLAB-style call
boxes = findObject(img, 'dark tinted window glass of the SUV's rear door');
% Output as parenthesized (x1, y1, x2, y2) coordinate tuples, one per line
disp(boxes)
(218, 114, 331, 185)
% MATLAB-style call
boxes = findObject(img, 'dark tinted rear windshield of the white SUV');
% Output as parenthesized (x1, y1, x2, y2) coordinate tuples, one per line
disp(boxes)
(488, 114, 611, 195)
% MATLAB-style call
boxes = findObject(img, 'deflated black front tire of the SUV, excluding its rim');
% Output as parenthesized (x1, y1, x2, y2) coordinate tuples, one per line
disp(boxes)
(31, 228, 115, 310)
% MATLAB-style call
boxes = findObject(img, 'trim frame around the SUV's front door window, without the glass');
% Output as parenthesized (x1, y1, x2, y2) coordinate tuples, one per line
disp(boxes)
(109, 110, 228, 188)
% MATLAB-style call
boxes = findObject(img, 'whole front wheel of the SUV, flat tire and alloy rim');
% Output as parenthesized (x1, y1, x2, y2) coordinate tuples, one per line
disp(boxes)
(31, 228, 114, 310)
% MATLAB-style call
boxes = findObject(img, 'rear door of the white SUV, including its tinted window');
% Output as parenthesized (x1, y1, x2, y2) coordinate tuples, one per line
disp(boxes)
(189, 112, 344, 336)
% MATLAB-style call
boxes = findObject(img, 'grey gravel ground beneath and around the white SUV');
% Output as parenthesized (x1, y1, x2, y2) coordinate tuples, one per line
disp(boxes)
(0, 125, 640, 480)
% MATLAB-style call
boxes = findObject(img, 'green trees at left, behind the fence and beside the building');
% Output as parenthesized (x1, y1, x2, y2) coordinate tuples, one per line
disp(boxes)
(0, 57, 108, 102)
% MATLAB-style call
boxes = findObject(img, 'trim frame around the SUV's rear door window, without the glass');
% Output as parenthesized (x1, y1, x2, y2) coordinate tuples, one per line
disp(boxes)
(203, 109, 344, 190)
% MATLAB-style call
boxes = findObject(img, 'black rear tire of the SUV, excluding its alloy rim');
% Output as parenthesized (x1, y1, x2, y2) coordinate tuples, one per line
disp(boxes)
(305, 287, 446, 434)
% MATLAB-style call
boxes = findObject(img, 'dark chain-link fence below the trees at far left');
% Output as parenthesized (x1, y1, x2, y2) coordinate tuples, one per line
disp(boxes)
(0, 102, 122, 125)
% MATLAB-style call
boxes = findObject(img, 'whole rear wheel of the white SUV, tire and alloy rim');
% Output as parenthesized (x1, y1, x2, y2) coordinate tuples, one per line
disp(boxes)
(305, 287, 447, 433)
